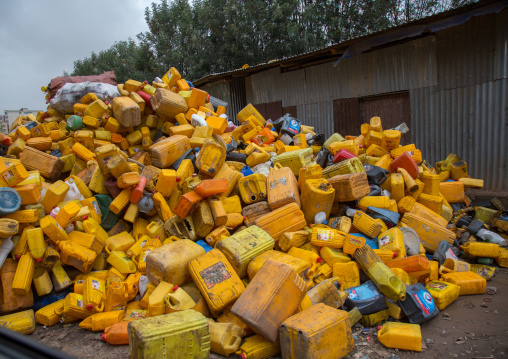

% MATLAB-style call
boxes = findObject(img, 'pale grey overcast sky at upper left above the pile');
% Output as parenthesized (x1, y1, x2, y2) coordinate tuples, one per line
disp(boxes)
(0, 0, 153, 114)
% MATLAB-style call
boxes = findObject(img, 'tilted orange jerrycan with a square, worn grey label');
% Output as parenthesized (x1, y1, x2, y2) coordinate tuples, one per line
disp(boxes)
(189, 250, 245, 316)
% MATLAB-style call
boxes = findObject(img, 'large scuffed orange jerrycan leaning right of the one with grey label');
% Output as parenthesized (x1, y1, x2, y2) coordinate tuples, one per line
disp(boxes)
(231, 259, 307, 342)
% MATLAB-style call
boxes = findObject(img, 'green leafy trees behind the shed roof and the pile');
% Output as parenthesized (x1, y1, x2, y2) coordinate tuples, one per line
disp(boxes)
(72, 0, 474, 82)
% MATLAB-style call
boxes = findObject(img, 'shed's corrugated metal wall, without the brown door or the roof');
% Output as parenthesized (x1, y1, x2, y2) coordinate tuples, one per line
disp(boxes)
(200, 9, 508, 190)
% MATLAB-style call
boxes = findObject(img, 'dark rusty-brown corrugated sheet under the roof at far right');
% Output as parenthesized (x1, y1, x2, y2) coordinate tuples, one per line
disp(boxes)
(436, 10, 508, 89)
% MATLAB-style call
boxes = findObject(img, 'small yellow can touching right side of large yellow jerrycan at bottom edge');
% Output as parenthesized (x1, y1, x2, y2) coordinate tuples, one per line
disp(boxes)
(208, 319, 244, 357)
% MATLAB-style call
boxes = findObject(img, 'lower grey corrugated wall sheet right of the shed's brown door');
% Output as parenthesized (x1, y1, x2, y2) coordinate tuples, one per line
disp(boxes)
(410, 79, 508, 190)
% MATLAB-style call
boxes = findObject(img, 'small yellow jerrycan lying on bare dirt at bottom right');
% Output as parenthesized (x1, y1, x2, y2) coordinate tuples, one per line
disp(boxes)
(377, 322, 422, 352)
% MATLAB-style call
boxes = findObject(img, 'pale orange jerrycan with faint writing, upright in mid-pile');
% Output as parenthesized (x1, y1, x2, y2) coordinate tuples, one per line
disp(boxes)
(266, 164, 300, 211)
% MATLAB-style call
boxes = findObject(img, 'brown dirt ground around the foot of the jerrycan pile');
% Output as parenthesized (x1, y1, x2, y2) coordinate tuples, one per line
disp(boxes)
(31, 268, 508, 359)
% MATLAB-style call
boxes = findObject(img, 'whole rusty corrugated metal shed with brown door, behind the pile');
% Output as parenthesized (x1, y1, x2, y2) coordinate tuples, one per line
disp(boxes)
(194, 1, 508, 196)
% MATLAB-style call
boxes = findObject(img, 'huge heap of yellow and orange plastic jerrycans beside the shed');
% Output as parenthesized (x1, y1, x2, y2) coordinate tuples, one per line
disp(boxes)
(0, 68, 508, 359)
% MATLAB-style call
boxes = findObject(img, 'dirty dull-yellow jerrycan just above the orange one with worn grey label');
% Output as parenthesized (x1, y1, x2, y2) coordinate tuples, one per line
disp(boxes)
(216, 226, 275, 278)
